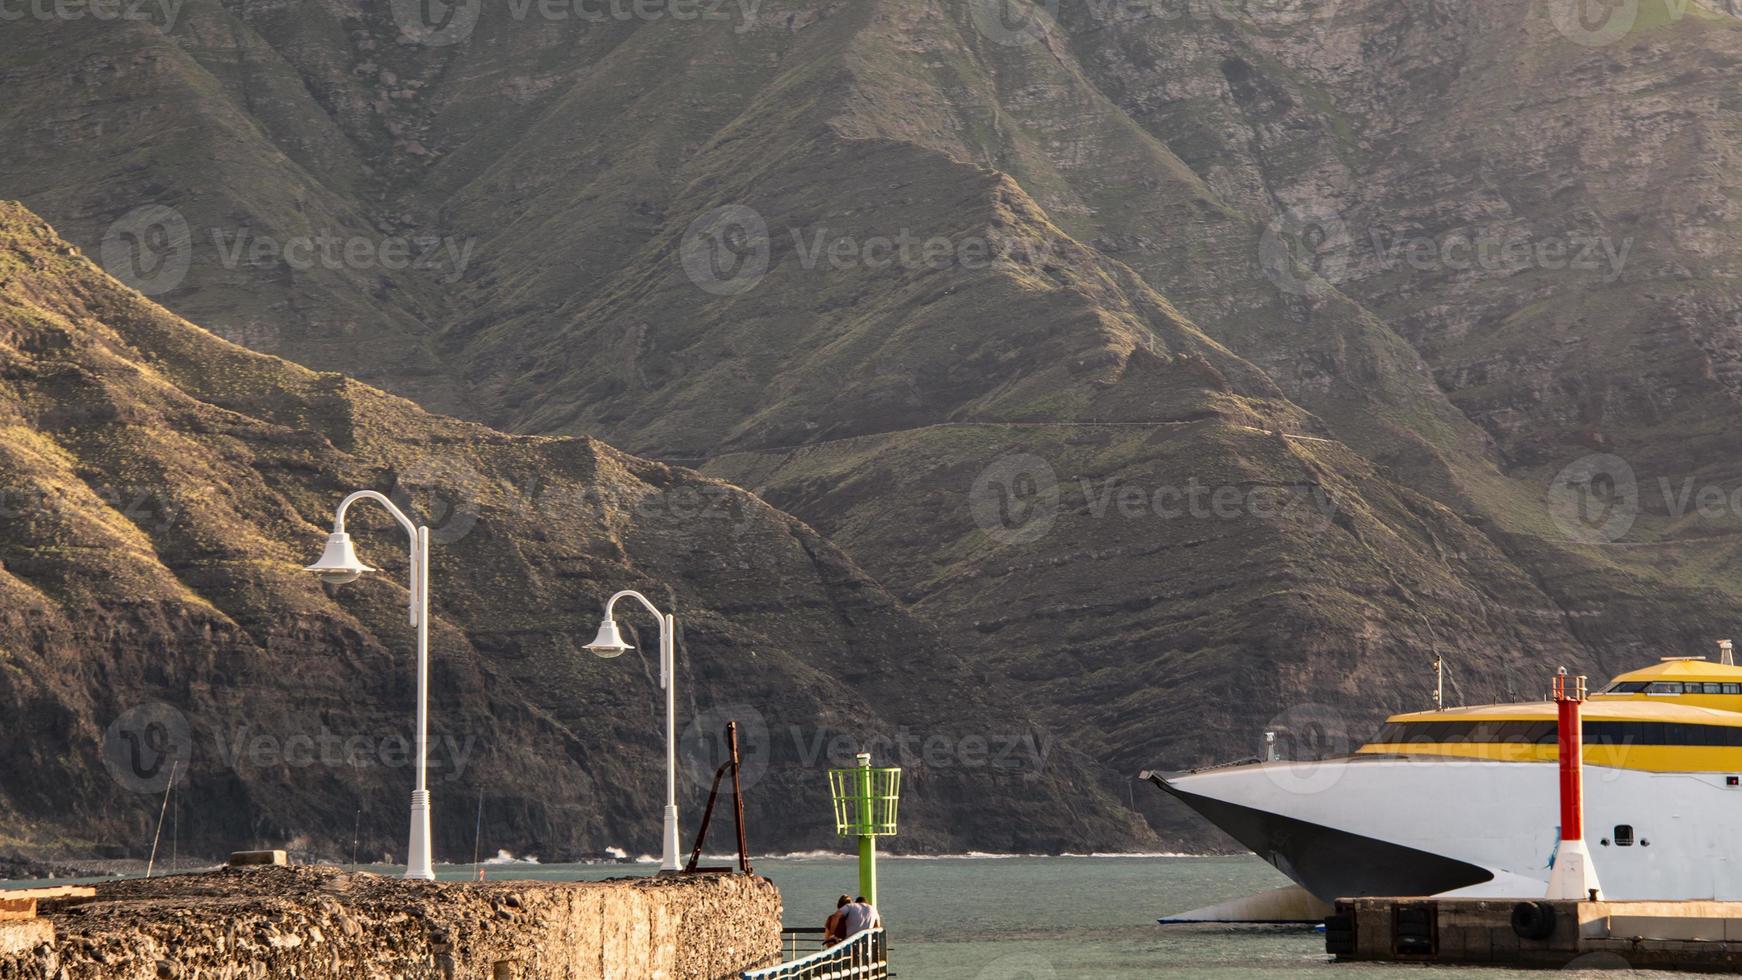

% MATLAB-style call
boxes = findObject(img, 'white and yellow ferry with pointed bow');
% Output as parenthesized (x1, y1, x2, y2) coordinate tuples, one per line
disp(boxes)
(1143, 644, 1742, 902)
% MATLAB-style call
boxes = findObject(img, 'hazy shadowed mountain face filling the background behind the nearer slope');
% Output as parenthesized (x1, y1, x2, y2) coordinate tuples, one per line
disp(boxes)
(0, 0, 1742, 845)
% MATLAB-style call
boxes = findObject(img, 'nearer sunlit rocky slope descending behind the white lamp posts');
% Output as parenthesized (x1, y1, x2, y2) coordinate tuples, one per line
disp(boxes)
(0, 204, 1148, 860)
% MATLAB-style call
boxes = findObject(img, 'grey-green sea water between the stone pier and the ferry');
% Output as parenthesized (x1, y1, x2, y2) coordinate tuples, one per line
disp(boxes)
(456, 856, 1676, 980)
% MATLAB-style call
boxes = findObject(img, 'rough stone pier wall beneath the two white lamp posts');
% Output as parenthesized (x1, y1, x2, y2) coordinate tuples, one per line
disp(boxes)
(0, 867, 780, 980)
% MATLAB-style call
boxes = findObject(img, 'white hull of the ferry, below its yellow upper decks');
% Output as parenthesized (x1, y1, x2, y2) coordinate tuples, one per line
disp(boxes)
(1151, 755, 1742, 902)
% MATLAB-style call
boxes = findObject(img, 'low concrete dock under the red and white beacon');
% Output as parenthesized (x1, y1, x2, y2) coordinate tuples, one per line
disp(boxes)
(1326, 898, 1742, 973)
